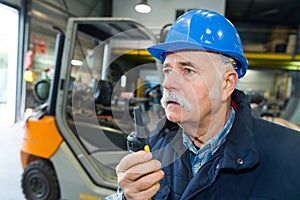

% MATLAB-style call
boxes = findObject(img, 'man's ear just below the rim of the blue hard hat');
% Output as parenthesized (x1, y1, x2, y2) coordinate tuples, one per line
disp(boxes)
(222, 70, 238, 101)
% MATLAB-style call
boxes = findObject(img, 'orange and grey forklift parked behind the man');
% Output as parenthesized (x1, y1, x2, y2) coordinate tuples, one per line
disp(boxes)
(21, 18, 164, 200)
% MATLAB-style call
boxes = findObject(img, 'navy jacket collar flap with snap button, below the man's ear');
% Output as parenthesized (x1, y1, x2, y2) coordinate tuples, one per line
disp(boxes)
(222, 90, 259, 170)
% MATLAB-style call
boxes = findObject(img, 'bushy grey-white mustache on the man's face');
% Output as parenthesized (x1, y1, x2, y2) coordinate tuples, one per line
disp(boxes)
(160, 90, 192, 111)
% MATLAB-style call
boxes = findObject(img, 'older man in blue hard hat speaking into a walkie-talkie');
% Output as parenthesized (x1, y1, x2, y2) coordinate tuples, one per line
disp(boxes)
(108, 9, 300, 200)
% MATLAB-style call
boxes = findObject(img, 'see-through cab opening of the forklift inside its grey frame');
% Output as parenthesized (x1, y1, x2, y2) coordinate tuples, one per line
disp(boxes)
(66, 20, 163, 171)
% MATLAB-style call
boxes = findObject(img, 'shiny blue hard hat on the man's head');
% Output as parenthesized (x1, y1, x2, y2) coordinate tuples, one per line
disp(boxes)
(148, 9, 248, 78)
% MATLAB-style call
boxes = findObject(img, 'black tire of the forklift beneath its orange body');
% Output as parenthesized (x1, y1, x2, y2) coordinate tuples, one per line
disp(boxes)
(21, 160, 60, 200)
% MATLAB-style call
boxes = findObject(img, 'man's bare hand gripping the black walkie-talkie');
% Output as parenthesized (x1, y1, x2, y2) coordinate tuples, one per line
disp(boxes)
(116, 151, 164, 199)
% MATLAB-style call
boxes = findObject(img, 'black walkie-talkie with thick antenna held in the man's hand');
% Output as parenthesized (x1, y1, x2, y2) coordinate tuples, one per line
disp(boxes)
(127, 106, 150, 152)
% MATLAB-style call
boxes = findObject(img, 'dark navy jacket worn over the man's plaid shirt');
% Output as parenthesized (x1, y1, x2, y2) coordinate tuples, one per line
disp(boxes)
(150, 90, 300, 200)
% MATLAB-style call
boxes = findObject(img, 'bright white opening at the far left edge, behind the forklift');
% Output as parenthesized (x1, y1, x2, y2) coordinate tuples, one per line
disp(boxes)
(0, 4, 19, 124)
